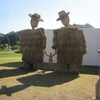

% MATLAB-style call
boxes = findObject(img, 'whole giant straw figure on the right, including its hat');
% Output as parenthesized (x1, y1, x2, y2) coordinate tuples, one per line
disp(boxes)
(52, 10, 86, 73)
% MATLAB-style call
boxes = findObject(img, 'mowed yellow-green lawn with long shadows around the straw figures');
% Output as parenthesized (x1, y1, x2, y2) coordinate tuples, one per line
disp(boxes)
(0, 52, 98, 100)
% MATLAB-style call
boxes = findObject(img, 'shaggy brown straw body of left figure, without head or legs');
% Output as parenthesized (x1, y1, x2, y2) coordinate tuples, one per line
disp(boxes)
(20, 28, 46, 69)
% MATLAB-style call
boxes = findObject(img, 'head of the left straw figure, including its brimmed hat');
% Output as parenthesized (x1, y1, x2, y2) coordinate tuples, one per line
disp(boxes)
(29, 13, 43, 29)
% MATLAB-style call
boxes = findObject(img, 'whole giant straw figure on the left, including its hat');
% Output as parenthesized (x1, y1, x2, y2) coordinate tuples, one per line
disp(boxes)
(20, 13, 46, 70)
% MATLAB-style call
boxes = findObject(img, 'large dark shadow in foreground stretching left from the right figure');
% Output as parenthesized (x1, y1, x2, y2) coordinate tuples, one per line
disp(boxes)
(0, 72, 79, 96)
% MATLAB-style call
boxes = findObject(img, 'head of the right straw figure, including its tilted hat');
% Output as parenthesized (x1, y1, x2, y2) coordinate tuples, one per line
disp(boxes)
(56, 10, 70, 26)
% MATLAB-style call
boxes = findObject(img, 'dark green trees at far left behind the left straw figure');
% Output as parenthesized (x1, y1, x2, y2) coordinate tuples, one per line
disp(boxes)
(0, 31, 23, 51)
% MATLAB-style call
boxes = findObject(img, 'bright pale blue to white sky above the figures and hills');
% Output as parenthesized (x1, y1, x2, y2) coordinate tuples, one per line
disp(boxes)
(0, 0, 100, 34)
